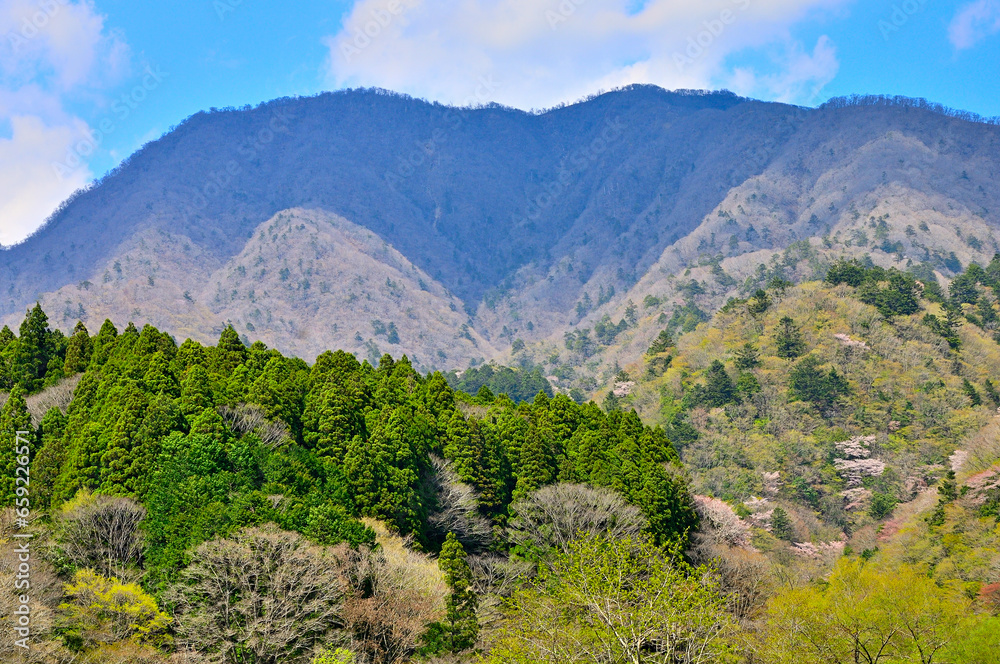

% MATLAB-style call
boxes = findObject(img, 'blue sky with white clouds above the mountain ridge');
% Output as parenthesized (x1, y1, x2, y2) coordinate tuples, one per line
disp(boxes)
(0, 0, 1000, 245)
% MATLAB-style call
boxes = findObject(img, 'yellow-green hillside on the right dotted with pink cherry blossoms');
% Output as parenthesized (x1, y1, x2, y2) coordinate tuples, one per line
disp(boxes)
(608, 260, 1000, 583)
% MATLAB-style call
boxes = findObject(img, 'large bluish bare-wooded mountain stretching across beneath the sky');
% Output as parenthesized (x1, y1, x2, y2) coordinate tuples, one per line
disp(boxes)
(0, 86, 1000, 367)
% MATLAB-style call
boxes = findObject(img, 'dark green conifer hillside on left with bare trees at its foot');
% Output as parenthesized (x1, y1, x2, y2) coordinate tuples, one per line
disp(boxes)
(0, 307, 697, 662)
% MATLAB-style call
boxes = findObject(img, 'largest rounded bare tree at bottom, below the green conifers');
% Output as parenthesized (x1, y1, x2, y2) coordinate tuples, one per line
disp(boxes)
(167, 526, 344, 664)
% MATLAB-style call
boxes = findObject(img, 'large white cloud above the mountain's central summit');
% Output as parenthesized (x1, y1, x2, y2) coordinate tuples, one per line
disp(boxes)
(326, 0, 849, 108)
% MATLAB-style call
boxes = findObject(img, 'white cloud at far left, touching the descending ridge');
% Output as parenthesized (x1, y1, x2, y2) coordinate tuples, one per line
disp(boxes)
(0, 0, 131, 245)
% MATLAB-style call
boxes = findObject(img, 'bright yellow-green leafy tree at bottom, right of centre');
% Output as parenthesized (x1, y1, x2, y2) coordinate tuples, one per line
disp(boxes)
(485, 536, 732, 664)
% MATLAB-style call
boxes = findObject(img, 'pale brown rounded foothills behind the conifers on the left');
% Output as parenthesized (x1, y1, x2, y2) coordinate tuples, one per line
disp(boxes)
(29, 209, 497, 367)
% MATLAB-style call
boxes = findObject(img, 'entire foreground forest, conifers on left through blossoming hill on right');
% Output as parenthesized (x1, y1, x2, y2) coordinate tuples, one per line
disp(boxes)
(0, 257, 1000, 664)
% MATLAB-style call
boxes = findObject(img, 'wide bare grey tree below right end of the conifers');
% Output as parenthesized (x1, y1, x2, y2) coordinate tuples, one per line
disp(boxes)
(508, 484, 646, 553)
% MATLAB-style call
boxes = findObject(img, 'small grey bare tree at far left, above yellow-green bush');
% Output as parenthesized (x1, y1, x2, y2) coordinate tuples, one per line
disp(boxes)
(59, 492, 146, 579)
